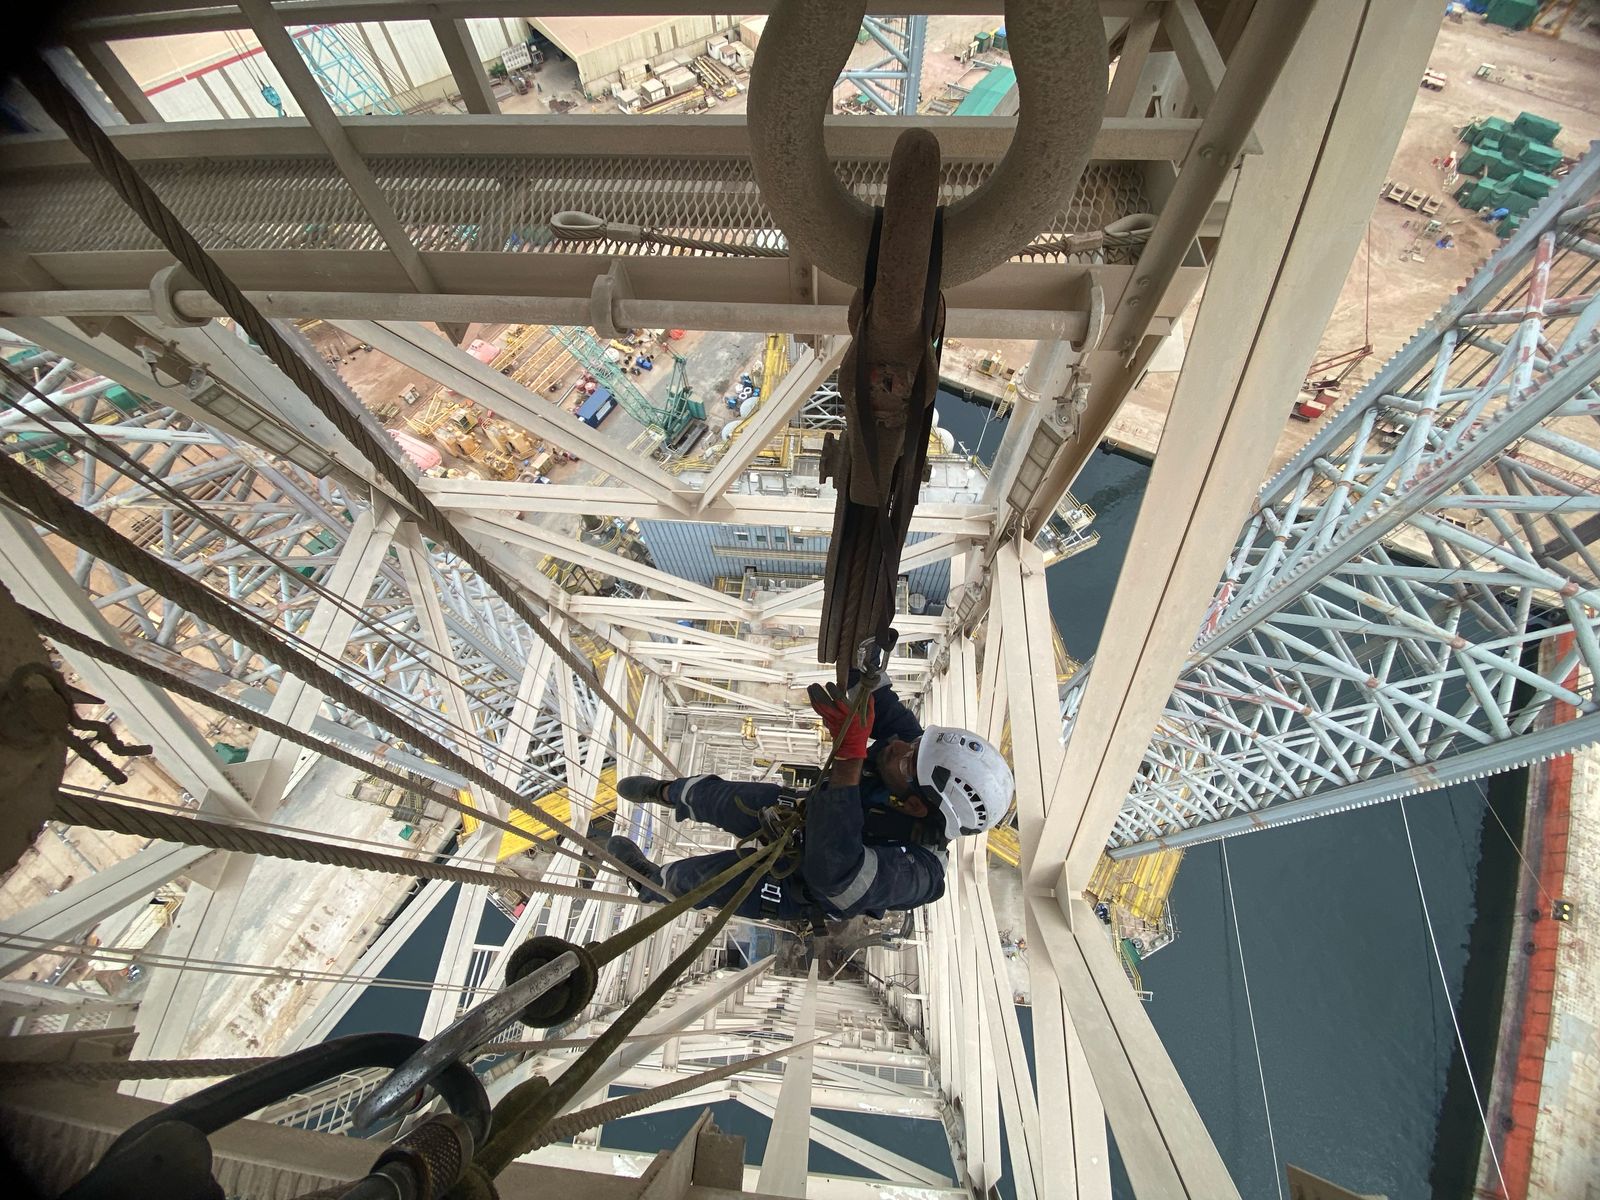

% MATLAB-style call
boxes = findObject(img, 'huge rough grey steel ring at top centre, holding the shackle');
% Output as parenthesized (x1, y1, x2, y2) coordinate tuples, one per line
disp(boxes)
(749, 0, 1107, 288)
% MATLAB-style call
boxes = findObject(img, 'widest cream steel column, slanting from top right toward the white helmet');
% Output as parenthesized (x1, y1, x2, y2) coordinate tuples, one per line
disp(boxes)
(1029, 0, 1438, 896)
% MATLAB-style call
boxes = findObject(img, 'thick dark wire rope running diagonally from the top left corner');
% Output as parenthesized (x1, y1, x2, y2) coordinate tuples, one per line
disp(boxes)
(16, 59, 678, 774)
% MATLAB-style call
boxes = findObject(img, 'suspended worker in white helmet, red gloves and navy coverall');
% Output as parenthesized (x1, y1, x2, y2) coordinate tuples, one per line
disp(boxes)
(608, 683, 1013, 923)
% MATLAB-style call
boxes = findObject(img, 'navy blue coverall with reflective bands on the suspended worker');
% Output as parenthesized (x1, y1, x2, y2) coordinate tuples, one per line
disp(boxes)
(662, 685, 944, 920)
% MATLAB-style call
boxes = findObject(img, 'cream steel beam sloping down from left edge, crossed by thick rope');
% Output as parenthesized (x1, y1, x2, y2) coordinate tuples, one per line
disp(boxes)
(0, 512, 251, 816)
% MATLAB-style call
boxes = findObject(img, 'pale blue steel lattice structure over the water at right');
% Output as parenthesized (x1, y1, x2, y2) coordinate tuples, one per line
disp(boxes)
(1100, 150, 1600, 853)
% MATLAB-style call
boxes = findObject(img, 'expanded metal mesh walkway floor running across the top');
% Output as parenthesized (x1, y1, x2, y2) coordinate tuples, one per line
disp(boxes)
(0, 155, 1149, 261)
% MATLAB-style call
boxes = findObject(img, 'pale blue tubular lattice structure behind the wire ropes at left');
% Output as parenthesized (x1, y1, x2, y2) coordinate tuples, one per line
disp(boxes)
(0, 395, 592, 790)
